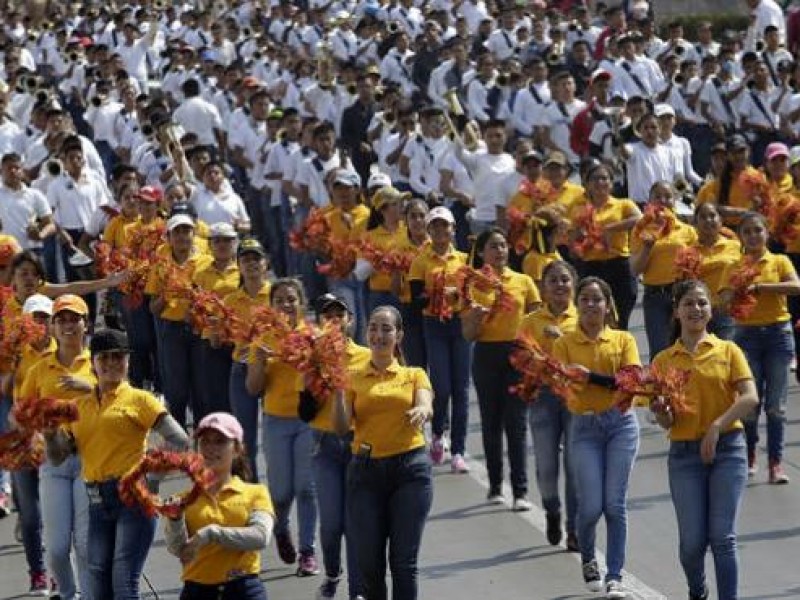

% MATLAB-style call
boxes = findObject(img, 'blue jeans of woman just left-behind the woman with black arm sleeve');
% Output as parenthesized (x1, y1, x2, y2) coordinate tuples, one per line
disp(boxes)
(528, 390, 578, 532)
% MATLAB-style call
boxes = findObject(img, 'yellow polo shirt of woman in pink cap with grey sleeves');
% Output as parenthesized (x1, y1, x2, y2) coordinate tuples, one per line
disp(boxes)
(181, 476, 275, 585)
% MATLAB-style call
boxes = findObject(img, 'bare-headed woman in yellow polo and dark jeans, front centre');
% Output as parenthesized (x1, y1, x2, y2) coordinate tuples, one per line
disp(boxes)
(332, 306, 433, 600)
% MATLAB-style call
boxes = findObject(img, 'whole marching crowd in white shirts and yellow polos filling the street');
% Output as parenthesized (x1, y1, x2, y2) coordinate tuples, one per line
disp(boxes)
(0, 0, 800, 600)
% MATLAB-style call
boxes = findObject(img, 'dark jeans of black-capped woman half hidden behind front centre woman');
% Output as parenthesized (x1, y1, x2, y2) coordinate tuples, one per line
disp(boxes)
(313, 430, 361, 598)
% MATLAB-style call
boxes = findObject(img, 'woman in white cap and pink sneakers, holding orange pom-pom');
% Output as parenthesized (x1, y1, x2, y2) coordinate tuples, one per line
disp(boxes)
(408, 206, 471, 473)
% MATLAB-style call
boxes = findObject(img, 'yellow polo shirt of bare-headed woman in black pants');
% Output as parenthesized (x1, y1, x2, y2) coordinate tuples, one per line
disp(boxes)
(470, 267, 542, 342)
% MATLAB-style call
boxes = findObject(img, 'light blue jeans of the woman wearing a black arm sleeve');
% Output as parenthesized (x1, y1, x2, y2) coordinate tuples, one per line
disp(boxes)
(571, 408, 639, 581)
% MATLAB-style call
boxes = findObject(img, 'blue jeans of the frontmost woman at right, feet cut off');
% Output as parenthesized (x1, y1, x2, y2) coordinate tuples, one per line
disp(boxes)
(668, 431, 747, 600)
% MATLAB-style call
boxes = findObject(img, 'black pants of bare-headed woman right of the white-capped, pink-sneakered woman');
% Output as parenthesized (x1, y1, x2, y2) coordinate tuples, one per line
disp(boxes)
(472, 342, 528, 498)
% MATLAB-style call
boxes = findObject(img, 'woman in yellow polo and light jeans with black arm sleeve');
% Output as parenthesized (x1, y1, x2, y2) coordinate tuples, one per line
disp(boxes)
(553, 277, 639, 598)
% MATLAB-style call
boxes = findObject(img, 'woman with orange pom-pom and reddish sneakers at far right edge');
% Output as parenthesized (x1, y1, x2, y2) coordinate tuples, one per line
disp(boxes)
(721, 213, 800, 484)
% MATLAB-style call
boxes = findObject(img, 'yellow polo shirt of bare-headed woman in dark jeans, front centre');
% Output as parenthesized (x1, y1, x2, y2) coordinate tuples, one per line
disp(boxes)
(347, 361, 431, 458)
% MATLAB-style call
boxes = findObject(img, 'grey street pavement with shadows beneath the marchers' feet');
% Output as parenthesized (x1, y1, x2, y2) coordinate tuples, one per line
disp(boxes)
(0, 300, 800, 600)
